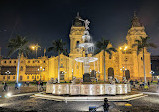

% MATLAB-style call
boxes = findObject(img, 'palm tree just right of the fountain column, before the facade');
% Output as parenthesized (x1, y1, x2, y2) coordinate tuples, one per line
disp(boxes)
(96, 38, 117, 82)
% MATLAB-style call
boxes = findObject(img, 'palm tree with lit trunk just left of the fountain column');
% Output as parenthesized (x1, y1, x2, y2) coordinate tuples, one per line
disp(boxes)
(48, 39, 66, 83)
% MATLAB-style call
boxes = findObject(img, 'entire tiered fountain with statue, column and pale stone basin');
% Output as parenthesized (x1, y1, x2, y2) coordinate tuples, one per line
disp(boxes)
(46, 18, 131, 96)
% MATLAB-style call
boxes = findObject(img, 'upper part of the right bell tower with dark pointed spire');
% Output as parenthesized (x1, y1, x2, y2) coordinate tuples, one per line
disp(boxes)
(126, 12, 147, 47)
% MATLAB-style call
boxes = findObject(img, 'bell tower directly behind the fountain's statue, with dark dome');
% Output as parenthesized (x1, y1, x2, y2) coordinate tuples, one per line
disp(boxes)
(69, 13, 85, 58)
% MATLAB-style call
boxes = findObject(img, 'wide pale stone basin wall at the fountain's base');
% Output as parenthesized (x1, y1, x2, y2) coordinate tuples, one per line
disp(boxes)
(46, 84, 131, 95)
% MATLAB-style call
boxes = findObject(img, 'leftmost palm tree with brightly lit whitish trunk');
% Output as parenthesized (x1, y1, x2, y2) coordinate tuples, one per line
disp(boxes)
(8, 35, 30, 83)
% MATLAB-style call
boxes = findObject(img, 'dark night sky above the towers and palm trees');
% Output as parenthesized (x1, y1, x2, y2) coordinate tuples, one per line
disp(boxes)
(0, 0, 159, 57)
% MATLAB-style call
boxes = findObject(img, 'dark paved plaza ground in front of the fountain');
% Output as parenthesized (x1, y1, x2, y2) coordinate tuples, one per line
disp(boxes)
(0, 83, 159, 112)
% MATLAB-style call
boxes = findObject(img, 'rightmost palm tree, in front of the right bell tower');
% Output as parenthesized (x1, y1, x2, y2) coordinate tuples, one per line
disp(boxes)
(132, 36, 156, 83)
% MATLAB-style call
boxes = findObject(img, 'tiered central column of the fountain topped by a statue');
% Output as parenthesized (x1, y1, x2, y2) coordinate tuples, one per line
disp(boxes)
(75, 19, 98, 82)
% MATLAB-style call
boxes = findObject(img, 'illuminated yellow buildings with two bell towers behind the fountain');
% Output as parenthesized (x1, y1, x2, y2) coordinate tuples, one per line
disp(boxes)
(0, 15, 151, 81)
